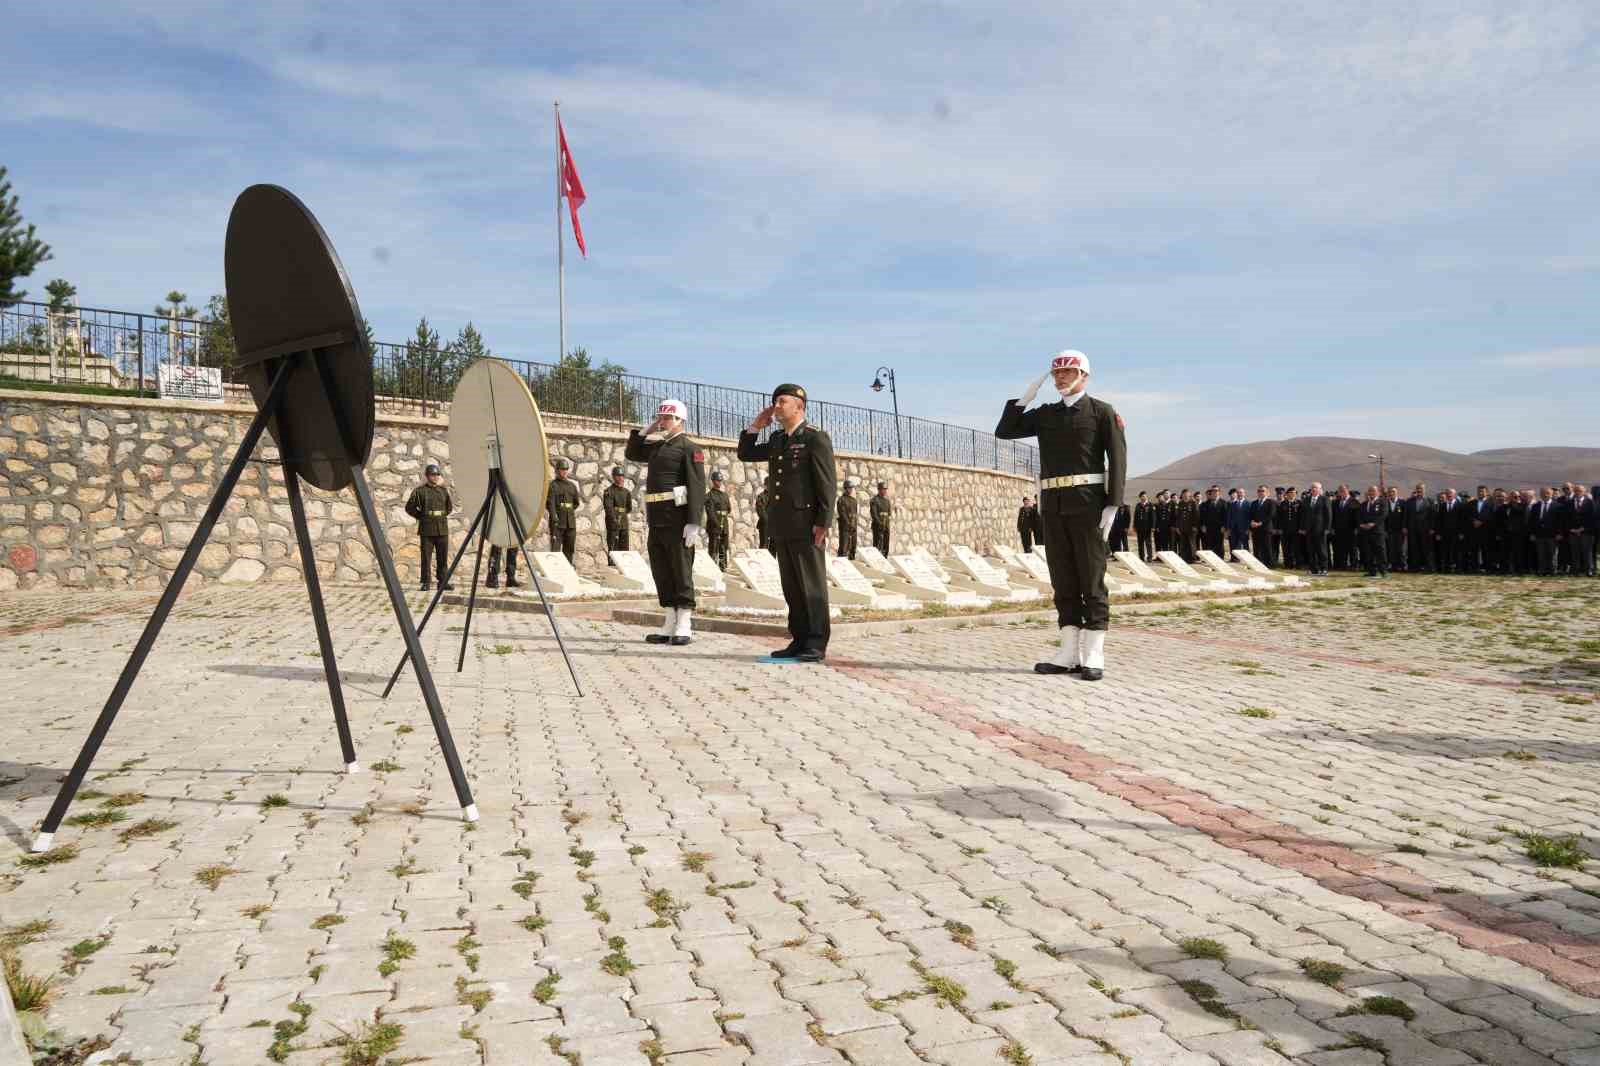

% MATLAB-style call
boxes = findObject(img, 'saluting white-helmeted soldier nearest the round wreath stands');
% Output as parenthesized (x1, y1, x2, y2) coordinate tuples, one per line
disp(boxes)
(624, 400, 706, 645)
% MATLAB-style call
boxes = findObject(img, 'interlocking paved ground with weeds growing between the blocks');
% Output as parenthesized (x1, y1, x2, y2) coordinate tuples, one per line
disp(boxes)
(0, 578, 1600, 1066)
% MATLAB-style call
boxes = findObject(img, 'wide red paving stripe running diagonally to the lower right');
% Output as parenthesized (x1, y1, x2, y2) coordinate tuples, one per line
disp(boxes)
(827, 656, 1600, 997)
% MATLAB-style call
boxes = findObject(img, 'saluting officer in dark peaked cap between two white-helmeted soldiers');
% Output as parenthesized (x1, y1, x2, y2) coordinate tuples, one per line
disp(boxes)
(739, 384, 838, 663)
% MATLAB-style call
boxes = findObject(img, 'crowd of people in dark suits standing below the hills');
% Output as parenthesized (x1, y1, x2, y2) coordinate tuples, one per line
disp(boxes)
(1100, 482, 1600, 578)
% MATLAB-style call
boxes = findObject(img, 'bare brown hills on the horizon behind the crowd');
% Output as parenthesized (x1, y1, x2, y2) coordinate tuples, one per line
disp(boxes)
(1128, 437, 1600, 498)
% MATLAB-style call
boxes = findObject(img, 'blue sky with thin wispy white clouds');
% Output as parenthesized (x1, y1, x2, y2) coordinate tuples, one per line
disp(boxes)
(0, 0, 1600, 471)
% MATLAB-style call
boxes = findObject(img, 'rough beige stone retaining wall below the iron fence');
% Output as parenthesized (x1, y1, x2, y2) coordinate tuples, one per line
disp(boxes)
(0, 389, 1034, 592)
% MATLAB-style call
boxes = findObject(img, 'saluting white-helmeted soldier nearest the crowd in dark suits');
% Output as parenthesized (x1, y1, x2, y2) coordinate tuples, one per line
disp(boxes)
(995, 351, 1128, 680)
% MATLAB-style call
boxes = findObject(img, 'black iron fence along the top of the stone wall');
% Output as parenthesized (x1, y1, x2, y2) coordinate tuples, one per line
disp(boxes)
(0, 294, 1038, 474)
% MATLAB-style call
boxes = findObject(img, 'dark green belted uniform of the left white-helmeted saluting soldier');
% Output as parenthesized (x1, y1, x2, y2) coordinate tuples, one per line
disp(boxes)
(624, 429, 706, 610)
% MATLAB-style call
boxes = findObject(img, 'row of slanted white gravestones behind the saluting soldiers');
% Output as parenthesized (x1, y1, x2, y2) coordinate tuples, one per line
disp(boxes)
(502, 544, 1304, 613)
